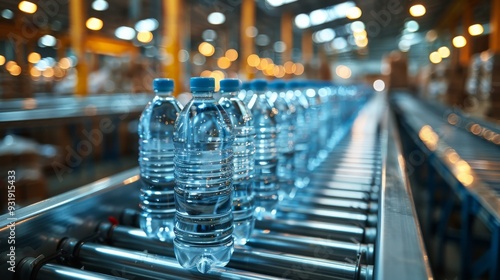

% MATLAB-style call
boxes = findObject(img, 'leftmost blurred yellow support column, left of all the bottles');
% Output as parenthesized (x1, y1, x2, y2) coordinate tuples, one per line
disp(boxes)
(69, 0, 88, 96)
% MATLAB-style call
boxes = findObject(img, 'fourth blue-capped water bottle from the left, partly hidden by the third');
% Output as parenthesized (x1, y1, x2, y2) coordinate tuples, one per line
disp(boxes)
(248, 79, 279, 220)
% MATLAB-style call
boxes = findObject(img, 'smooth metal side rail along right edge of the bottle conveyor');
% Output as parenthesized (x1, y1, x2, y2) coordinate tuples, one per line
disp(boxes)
(375, 109, 432, 279)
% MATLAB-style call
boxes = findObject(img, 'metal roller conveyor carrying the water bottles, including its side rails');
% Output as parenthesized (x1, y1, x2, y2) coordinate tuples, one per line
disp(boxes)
(0, 95, 431, 279)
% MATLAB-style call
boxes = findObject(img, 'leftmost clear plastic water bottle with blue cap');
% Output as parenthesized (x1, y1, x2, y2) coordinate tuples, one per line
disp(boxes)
(138, 79, 182, 241)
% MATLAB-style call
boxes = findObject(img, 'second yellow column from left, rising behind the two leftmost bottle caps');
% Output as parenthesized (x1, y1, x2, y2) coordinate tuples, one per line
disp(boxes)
(162, 0, 184, 96)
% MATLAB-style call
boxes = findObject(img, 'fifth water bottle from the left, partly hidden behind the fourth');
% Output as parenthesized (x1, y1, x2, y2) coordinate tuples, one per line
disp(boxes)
(268, 80, 296, 200)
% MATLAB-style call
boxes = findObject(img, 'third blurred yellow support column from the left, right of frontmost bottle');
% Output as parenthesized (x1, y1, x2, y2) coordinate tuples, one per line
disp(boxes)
(240, 0, 255, 80)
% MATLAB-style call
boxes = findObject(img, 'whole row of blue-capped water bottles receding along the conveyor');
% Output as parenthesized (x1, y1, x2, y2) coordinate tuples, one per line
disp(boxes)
(138, 77, 367, 273)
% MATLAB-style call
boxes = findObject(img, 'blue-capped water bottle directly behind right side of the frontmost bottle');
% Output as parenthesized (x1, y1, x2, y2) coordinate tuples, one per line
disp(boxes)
(219, 79, 255, 245)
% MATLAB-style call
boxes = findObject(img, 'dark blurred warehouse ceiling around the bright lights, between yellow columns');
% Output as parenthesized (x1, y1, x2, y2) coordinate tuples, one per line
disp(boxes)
(0, 0, 489, 64)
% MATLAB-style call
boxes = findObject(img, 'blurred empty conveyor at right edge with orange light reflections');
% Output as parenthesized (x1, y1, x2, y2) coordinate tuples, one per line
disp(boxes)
(391, 92, 500, 279)
